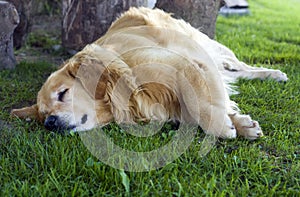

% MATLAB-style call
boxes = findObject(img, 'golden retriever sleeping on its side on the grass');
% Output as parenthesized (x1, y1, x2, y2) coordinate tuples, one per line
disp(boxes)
(11, 8, 288, 139)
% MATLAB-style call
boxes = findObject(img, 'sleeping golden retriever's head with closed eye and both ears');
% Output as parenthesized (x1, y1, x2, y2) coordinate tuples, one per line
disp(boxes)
(11, 45, 116, 131)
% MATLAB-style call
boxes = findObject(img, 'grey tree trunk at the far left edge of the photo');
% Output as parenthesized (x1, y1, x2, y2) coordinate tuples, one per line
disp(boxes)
(0, 1, 19, 70)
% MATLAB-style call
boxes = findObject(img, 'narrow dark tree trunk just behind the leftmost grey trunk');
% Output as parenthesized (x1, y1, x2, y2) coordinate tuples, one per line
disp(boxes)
(7, 0, 32, 49)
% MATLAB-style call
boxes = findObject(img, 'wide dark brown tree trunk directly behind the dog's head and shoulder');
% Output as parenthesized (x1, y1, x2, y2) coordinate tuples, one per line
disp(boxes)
(62, 0, 147, 50)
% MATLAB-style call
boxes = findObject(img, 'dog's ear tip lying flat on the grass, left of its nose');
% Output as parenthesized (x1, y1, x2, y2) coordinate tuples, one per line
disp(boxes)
(10, 104, 40, 120)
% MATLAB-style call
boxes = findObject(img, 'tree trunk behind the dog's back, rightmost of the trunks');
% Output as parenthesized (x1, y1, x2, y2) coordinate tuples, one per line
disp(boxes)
(155, 0, 221, 38)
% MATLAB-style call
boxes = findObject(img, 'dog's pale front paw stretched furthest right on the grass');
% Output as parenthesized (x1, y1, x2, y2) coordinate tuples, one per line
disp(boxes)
(232, 114, 263, 140)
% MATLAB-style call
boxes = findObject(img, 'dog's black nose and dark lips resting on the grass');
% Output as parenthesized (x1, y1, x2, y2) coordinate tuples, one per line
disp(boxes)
(44, 115, 76, 133)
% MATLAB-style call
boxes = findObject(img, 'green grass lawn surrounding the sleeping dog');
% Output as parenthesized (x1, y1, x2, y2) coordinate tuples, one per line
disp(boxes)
(0, 0, 300, 196)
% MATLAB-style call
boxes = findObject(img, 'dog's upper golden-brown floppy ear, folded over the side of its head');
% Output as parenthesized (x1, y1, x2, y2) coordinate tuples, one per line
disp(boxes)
(67, 59, 109, 99)
